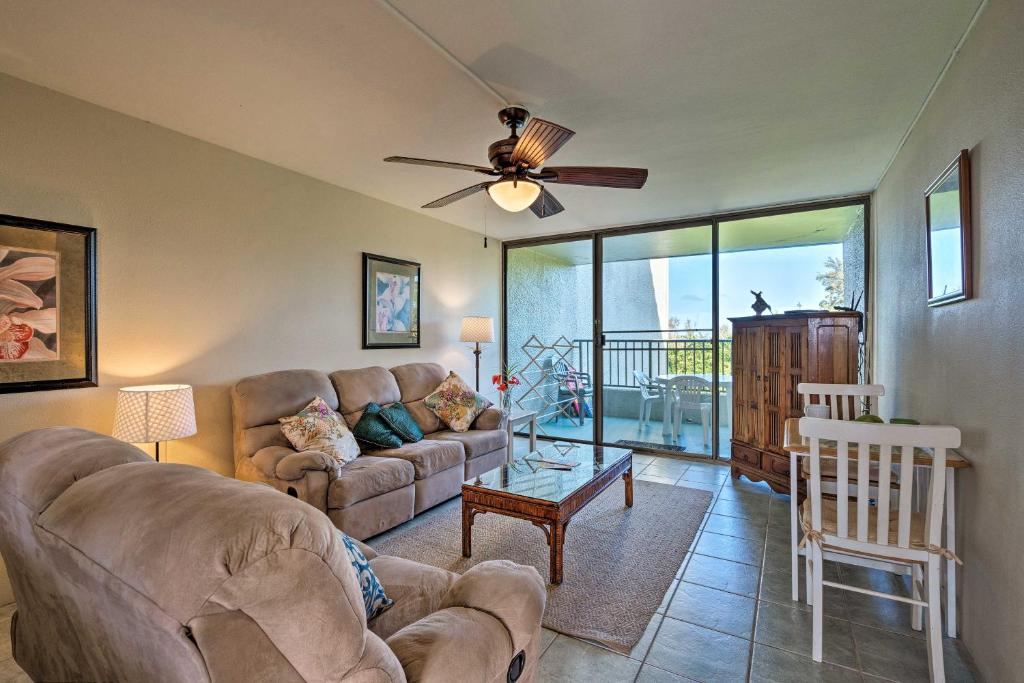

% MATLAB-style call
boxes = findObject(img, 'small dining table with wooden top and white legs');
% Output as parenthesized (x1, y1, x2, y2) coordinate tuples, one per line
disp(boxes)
(782, 418, 971, 638)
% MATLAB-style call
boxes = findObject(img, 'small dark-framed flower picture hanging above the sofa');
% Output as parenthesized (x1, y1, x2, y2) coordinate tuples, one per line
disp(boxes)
(362, 253, 420, 348)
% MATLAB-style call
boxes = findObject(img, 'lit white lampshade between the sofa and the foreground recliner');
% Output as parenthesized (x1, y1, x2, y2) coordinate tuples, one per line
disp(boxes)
(114, 384, 196, 443)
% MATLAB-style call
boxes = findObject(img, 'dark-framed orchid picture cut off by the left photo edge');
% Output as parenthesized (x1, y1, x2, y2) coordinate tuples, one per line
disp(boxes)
(0, 215, 96, 393)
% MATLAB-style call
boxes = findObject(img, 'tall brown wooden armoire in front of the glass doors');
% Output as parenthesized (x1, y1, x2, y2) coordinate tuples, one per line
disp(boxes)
(729, 310, 860, 494)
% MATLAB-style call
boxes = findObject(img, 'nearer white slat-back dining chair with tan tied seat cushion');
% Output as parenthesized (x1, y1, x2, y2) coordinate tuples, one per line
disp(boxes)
(800, 418, 961, 681)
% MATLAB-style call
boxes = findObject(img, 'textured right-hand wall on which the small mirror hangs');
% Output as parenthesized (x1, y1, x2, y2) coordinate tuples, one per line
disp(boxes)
(873, 0, 1024, 681)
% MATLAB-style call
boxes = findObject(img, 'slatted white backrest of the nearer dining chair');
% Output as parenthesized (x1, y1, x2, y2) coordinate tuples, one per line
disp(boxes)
(800, 418, 961, 549)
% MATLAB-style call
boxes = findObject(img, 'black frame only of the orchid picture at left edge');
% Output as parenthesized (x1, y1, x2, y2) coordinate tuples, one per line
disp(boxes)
(0, 214, 98, 393)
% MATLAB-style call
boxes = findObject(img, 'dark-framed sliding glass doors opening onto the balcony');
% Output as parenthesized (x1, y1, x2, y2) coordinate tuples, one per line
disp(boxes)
(503, 198, 869, 458)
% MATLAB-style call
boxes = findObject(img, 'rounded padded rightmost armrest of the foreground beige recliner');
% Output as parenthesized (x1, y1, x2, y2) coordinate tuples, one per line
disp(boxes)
(441, 560, 548, 652)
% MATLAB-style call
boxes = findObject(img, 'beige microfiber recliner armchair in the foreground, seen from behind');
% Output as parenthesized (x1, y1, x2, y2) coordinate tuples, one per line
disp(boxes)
(0, 427, 545, 683)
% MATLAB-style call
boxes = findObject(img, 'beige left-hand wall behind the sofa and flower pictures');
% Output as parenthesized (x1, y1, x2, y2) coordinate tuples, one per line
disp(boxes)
(0, 75, 501, 604)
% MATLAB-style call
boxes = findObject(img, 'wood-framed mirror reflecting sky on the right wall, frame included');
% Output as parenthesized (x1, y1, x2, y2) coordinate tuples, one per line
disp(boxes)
(925, 150, 971, 306)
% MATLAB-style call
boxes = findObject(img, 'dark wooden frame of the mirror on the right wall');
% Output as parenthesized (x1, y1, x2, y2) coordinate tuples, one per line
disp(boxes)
(925, 150, 974, 306)
